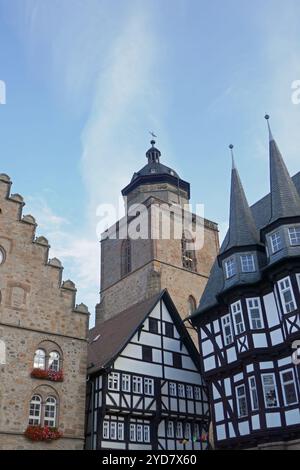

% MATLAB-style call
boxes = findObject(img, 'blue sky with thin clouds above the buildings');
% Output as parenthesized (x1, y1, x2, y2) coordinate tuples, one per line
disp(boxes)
(0, 0, 300, 324)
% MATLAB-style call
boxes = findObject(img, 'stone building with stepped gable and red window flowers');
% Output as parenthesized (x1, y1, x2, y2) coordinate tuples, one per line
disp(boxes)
(0, 174, 89, 450)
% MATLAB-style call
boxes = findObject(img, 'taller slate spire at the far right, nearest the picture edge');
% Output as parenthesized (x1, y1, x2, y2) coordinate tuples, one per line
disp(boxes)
(265, 115, 300, 223)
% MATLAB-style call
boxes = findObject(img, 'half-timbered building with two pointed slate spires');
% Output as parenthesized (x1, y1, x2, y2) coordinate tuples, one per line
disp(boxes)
(190, 116, 300, 449)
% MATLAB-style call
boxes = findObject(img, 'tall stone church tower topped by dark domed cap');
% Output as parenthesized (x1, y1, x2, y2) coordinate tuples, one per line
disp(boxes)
(96, 141, 219, 342)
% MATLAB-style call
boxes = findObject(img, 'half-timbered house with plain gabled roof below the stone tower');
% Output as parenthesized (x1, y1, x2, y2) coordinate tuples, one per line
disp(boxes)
(86, 291, 209, 450)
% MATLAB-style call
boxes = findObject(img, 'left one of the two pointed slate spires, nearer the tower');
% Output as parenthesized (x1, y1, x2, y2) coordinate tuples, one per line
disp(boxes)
(223, 145, 259, 252)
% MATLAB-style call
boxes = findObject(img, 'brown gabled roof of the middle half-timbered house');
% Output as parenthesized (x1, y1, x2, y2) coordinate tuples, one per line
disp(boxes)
(88, 289, 199, 374)
